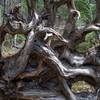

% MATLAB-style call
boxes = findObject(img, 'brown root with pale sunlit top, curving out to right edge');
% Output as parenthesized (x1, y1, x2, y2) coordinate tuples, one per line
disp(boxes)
(67, 23, 100, 45)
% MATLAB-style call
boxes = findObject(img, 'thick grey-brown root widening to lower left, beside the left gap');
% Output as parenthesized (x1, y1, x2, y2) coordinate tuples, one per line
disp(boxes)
(3, 31, 34, 81)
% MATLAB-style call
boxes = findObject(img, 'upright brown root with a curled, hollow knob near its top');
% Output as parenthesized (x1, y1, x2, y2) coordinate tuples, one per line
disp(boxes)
(63, 0, 80, 39)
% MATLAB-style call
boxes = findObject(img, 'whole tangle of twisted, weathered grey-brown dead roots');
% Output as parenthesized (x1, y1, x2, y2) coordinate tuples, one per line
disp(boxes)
(0, 0, 100, 100)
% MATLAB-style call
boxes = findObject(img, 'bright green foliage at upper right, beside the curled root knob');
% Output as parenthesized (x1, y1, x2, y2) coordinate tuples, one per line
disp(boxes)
(76, 0, 96, 25)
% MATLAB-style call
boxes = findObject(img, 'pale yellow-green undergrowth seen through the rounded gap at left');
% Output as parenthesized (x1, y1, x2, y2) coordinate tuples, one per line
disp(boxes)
(2, 34, 25, 57)
